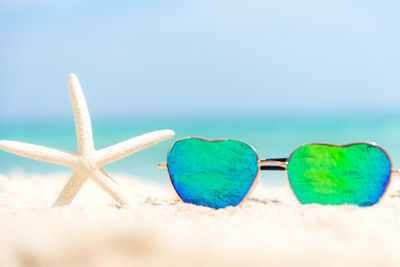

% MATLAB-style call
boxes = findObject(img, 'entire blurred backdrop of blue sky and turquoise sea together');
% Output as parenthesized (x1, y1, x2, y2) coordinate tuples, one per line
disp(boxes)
(0, 0, 400, 184)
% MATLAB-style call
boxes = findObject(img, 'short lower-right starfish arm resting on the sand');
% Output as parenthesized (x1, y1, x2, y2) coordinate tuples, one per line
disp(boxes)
(91, 169, 135, 206)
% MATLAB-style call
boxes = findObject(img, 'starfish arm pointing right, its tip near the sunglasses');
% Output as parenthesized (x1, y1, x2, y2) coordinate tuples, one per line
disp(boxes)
(96, 130, 175, 166)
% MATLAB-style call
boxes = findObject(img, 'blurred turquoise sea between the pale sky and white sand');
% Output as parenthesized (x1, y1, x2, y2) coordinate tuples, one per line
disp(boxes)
(0, 113, 400, 184)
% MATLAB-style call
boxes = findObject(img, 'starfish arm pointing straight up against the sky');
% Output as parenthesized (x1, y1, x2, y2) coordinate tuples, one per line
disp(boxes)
(68, 73, 94, 155)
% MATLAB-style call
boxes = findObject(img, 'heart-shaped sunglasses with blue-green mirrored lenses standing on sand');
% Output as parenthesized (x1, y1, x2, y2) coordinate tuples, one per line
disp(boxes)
(158, 137, 400, 209)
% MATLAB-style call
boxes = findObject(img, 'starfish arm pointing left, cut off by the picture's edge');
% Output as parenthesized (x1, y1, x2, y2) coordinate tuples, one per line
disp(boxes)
(0, 140, 76, 167)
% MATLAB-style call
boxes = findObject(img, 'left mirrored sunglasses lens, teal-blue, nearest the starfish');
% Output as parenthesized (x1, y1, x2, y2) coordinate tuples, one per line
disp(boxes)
(167, 138, 259, 209)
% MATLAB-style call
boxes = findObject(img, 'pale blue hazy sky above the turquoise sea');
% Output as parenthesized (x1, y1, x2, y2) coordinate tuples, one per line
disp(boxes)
(0, 0, 400, 119)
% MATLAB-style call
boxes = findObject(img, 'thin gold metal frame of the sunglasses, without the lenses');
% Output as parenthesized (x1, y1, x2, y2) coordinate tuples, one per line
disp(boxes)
(157, 137, 400, 206)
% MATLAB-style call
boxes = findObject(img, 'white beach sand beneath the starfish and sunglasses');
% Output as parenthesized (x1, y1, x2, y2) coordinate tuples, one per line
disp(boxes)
(0, 173, 400, 267)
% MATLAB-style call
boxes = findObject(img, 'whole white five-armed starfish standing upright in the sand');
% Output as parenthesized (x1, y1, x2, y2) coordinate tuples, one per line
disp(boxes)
(0, 74, 174, 206)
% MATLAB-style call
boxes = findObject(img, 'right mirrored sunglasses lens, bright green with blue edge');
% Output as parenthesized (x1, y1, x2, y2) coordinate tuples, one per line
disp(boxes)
(287, 143, 391, 207)
